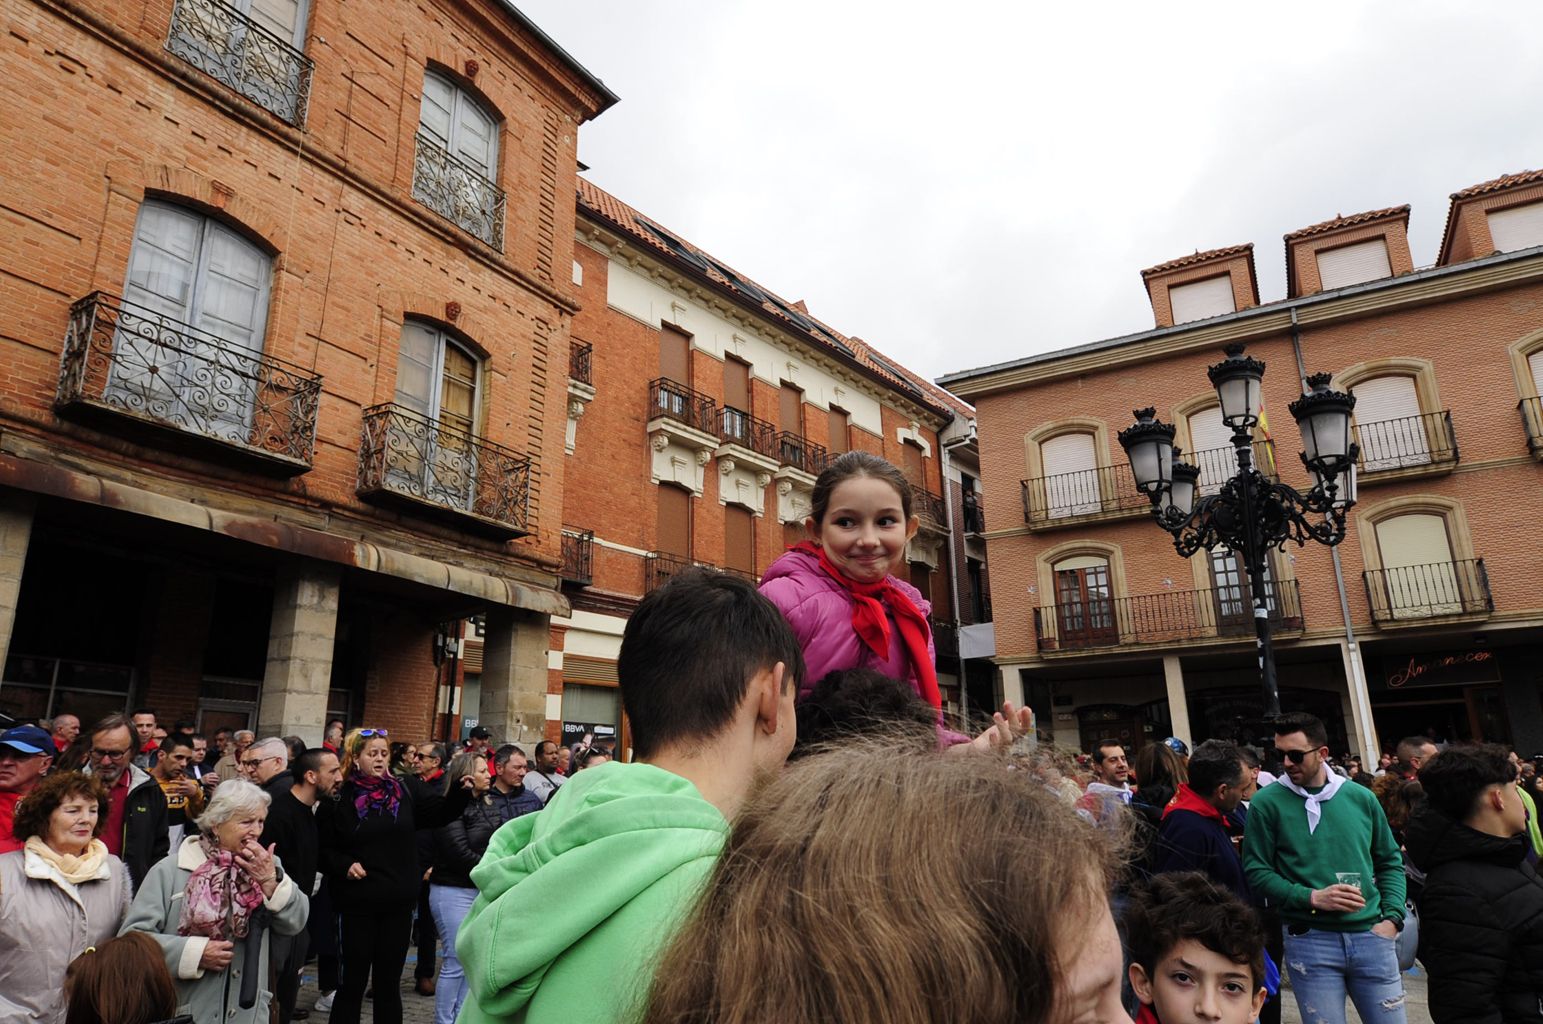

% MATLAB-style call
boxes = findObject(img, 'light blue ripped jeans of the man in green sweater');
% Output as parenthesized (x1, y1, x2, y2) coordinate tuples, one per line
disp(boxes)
(1282, 928, 1406, 1024)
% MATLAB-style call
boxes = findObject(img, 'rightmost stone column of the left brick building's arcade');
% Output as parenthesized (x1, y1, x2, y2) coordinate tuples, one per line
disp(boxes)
(477, 606, 551, 753)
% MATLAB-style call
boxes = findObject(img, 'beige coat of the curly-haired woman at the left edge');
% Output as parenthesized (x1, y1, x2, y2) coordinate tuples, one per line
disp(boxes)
(0, 850, 134, 1024)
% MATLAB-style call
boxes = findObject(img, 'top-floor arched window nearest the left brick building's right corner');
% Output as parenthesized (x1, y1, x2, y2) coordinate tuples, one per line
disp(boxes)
(412, 71, 503, 248)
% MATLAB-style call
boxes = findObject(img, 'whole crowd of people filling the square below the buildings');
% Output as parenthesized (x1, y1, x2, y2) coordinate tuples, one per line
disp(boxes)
(0, 453, 1543, 1024)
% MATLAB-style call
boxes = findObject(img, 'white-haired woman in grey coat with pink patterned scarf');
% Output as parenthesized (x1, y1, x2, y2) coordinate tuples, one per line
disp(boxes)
(123, 779, 310, 1024)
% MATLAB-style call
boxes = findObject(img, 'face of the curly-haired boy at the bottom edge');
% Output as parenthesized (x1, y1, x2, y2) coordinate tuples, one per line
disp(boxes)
(1131, 939, 1265, 1024)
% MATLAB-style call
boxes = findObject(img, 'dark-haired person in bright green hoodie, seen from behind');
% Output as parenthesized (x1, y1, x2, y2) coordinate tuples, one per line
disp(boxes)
(457, 569, 804, 1024)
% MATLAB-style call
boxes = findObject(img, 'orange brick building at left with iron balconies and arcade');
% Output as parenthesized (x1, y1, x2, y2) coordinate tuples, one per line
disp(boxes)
(0, 0, 616, 740)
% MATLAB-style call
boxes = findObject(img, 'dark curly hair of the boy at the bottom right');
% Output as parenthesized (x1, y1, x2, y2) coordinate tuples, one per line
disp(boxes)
(1125, 869, 1259, 995)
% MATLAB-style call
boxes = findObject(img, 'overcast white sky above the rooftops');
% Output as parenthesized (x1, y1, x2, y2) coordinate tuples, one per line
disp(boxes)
(515, 0, 1543, 378)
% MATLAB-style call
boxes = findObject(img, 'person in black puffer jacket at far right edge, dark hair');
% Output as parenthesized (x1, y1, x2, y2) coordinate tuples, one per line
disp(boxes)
(1406, 743, 1543, 1024)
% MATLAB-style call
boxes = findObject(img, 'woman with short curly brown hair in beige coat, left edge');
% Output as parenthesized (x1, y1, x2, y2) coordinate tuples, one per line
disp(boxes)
(0, 773, 134, 1024)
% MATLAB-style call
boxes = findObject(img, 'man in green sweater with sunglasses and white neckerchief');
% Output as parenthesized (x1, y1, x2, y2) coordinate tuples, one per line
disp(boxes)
(1244, 714, 1406, 1024)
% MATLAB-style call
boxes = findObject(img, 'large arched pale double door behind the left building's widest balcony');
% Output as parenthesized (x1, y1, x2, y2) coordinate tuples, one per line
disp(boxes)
(106, 200, 273, 444)
